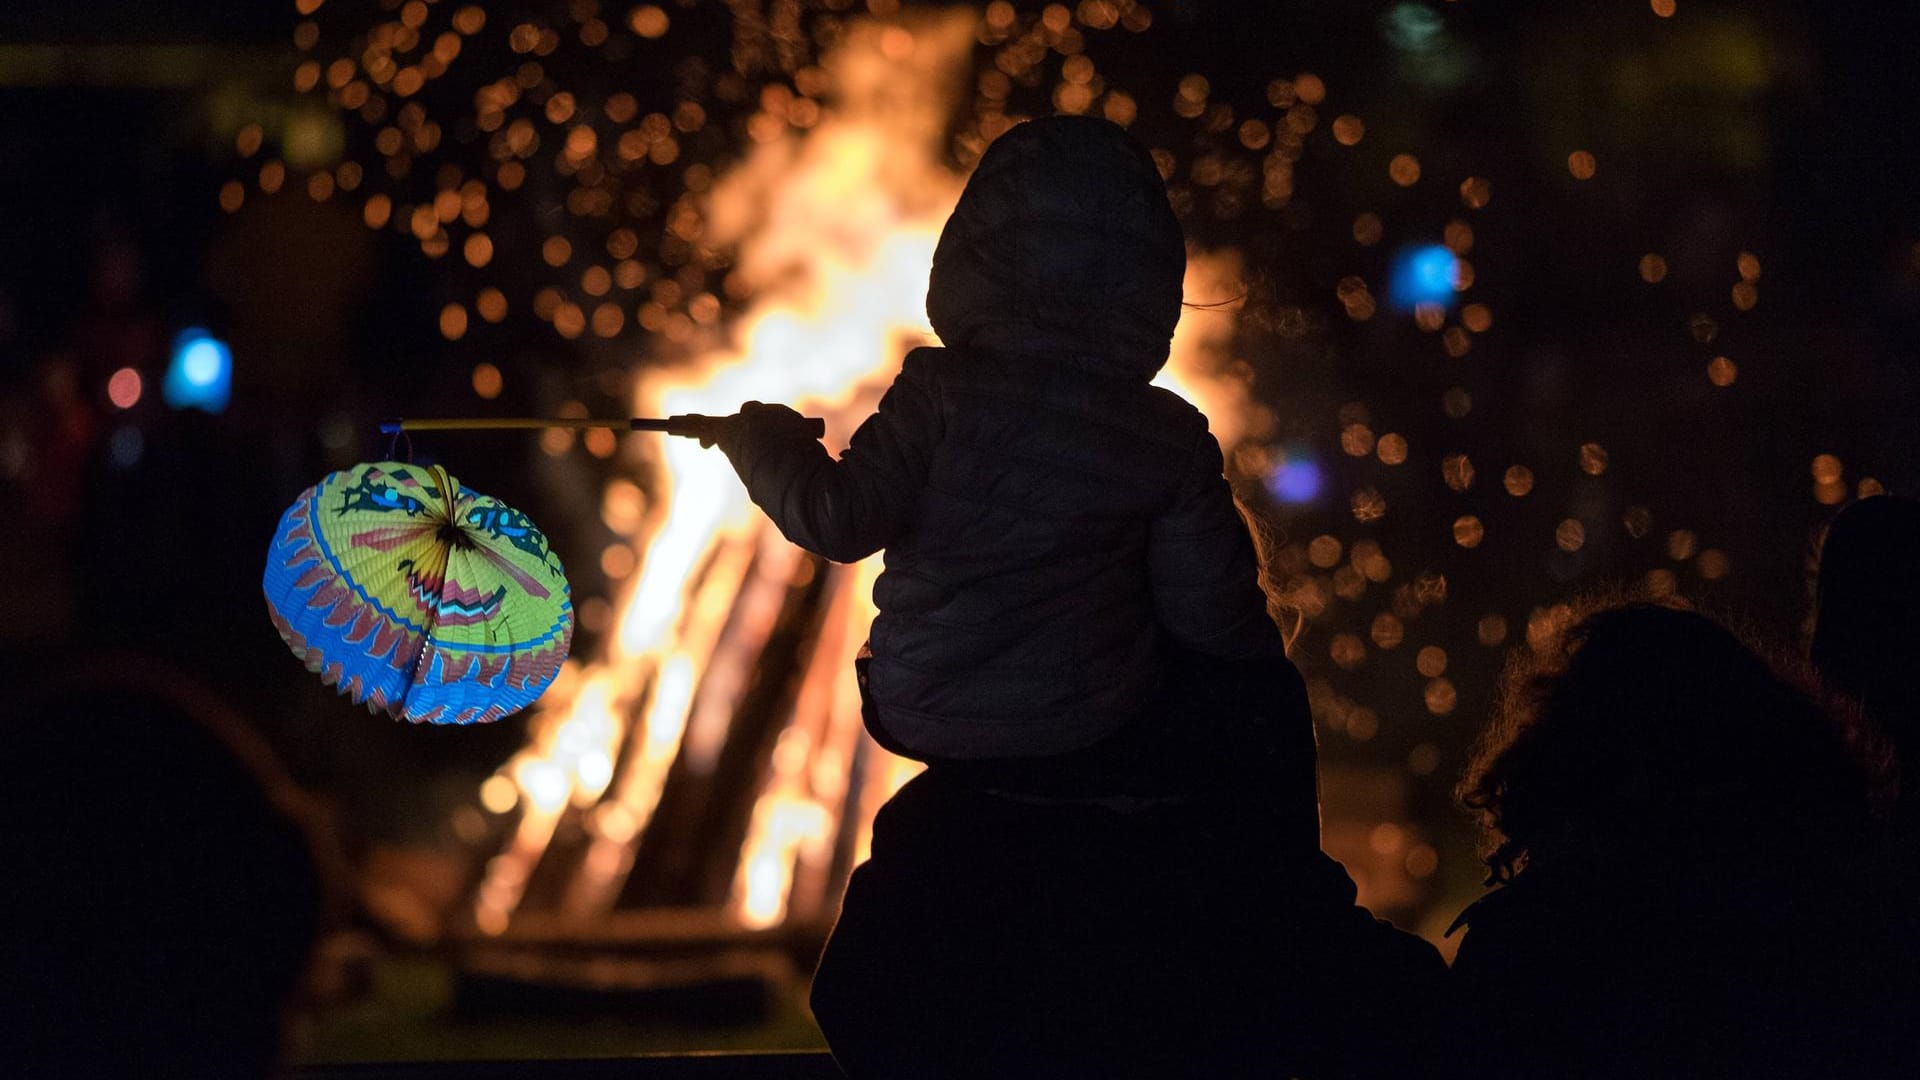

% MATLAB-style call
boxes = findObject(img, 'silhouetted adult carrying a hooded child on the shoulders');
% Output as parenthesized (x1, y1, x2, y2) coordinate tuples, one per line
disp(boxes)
(716, 117, 1438, 1076)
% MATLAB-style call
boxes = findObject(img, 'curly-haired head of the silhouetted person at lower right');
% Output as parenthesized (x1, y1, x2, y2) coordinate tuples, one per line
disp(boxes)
(1461, 603, 1868, 880)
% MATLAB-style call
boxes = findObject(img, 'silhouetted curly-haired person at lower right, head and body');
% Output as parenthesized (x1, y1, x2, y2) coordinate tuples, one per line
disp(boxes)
(1452, 603, 1870, 1076)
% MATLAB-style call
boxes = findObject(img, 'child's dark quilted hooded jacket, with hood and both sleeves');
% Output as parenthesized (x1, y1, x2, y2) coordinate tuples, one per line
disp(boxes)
(722, 117, 1284, 759)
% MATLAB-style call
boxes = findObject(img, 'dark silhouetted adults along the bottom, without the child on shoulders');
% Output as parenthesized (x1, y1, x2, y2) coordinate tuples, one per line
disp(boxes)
(11, 496, 1920, 1076)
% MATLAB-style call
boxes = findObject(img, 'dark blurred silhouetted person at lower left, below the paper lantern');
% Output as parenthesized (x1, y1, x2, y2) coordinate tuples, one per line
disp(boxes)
(0, 657, 321, 1078)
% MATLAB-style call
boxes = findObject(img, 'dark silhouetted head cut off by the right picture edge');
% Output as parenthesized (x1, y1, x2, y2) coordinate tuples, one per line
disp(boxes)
(1809, 496, 1920, 799)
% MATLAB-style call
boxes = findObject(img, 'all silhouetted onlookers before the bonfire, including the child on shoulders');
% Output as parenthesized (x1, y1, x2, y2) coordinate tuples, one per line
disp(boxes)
(0, 117, 1920, 1078)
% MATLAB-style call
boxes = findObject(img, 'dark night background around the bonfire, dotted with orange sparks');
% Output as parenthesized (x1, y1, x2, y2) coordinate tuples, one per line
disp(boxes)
(0, 0, 1920, 1059)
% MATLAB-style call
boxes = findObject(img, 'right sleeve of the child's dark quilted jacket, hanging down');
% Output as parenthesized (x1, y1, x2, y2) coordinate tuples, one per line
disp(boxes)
(1148, 430, 1286, 659)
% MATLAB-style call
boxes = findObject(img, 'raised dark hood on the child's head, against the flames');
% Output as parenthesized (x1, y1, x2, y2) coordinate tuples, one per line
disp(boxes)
(927, 115, 1187, 379)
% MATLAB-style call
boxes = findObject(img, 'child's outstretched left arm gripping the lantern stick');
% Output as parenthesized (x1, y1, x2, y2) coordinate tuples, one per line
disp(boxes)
(716, 361, 941, 563)
